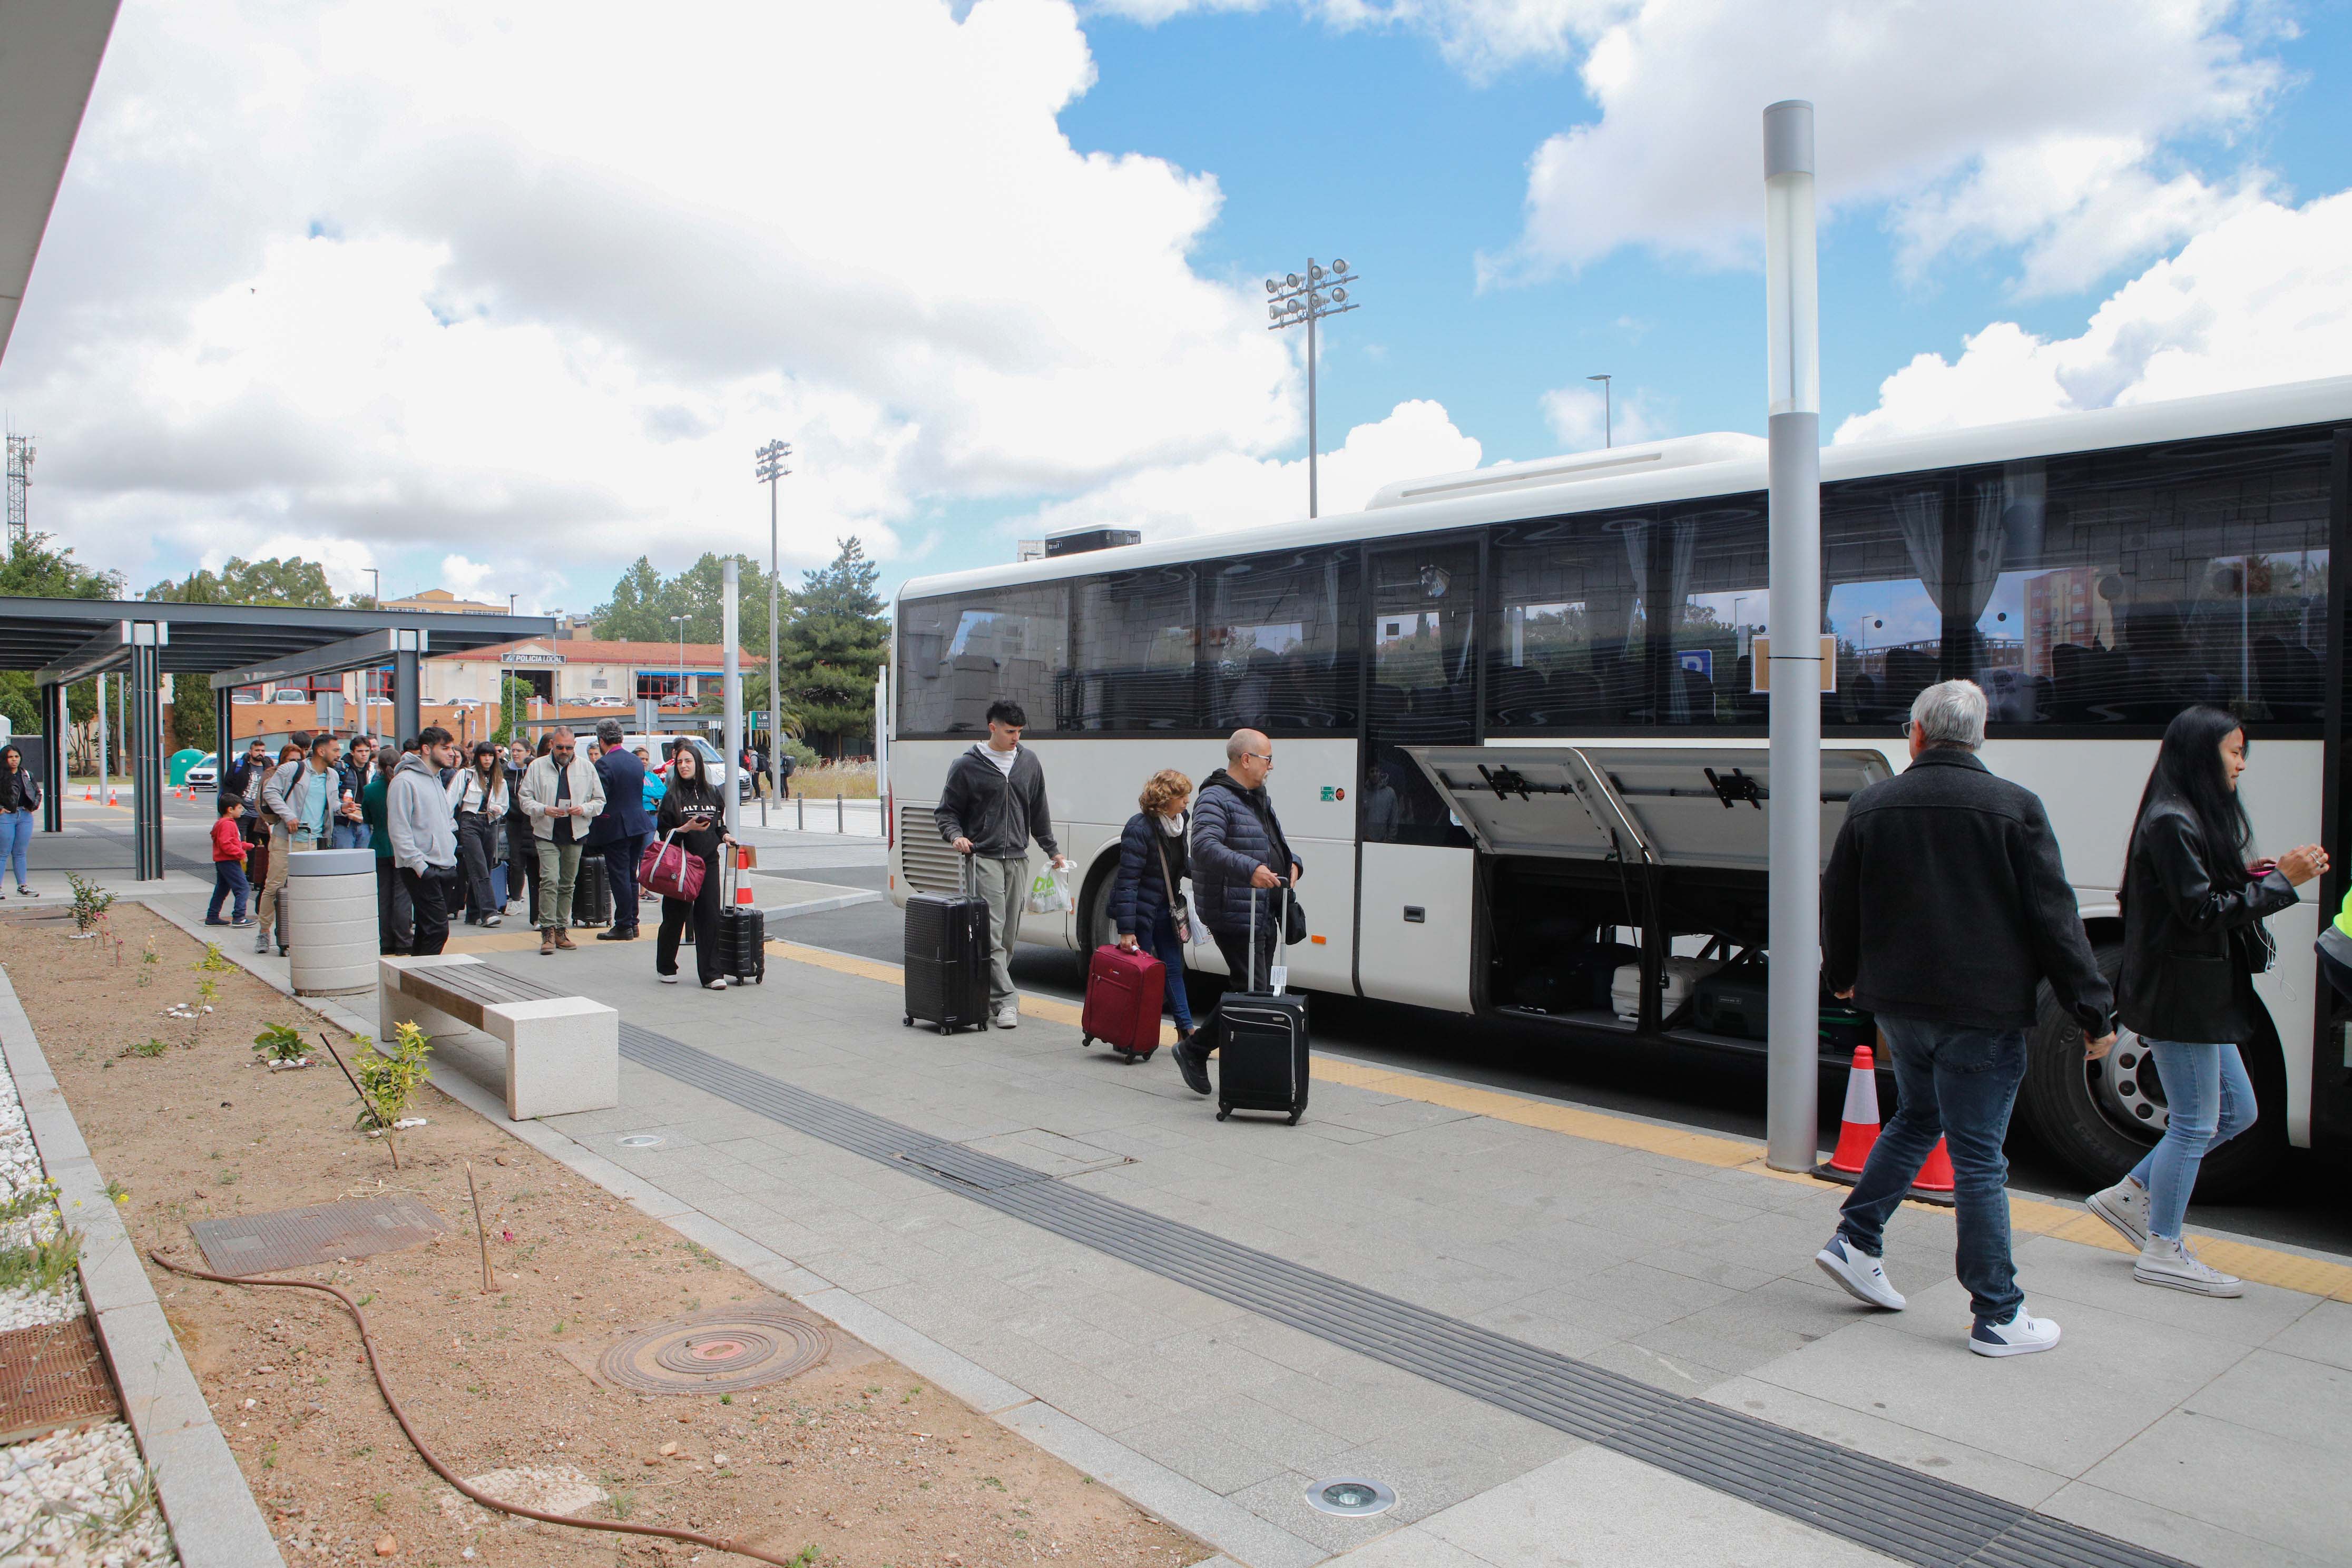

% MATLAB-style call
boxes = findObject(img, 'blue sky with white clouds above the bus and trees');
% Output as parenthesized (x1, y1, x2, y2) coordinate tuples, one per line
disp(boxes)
(0, 0, 2352, 609)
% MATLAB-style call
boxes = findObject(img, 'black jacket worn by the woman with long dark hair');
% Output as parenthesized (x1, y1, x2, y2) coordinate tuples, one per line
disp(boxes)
(2117, 801, 2296, 1046)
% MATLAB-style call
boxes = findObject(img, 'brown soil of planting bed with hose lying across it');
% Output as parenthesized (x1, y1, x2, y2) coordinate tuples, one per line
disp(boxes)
(5, 905, 1209, 1568)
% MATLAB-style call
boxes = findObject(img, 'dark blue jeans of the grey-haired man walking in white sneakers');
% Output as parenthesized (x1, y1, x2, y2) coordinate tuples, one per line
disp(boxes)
(1837, 1013, 2025, 1324)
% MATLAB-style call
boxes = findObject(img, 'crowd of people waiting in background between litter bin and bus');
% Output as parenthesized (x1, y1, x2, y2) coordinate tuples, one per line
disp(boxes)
(207, 719, 731, 989)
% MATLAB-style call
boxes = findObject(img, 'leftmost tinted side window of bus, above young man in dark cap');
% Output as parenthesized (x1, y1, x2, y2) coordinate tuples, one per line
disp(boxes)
(898, 583, 1070, 736)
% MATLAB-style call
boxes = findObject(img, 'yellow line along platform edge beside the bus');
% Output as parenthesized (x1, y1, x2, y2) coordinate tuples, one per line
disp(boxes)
(724, 938, 2352, 1302)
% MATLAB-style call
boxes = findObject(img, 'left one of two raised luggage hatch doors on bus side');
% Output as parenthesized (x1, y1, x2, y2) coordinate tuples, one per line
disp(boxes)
(1374, 745, 1644, 863)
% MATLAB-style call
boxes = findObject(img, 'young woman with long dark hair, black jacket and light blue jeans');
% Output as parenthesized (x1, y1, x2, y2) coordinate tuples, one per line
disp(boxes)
(2086, 708, 2328, 1295)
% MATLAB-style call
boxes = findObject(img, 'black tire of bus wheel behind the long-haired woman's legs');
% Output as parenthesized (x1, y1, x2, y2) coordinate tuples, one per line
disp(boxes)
(2018, 943, 2286, 1201)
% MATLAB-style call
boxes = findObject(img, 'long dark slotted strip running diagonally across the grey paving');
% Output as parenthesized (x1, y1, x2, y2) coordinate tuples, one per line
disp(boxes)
(555, 973, 2188, 1568)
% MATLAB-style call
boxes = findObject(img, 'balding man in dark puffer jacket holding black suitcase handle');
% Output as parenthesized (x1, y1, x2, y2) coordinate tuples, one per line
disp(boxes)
(1176, 729, 1306, 1095)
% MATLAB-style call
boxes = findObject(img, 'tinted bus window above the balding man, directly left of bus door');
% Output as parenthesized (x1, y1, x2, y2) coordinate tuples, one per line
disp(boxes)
(1200, 550, 1359, 736)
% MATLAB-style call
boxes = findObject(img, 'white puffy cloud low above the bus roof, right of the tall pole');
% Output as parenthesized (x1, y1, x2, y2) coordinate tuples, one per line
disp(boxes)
(1837, 190, 2352, 442)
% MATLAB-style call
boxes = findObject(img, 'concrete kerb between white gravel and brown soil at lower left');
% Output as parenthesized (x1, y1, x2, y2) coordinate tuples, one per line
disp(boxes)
(0, 968, 278, 1568)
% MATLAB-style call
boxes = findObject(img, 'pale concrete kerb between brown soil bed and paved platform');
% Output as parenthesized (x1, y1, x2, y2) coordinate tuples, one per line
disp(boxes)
(148, 903, 1331, 1568)
